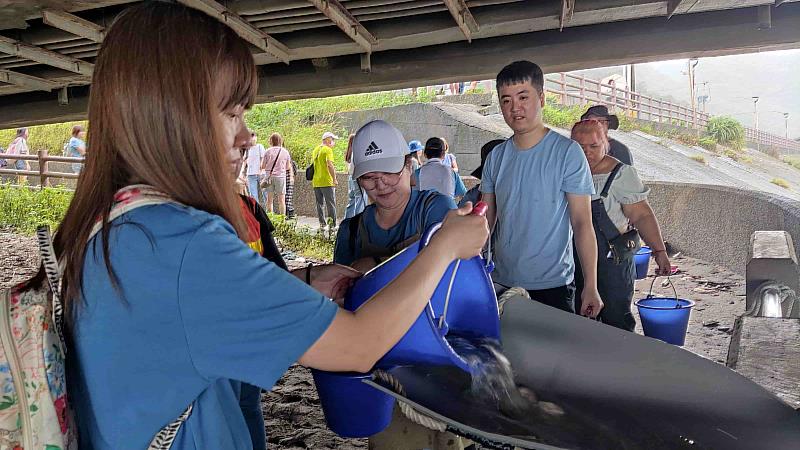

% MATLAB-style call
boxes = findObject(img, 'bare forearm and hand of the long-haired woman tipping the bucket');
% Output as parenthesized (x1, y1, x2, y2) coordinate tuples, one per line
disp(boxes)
(300, 207, 488, 372)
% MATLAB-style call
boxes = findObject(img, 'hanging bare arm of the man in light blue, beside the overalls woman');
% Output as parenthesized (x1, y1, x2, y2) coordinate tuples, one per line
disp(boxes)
(567, 193, 603, 318)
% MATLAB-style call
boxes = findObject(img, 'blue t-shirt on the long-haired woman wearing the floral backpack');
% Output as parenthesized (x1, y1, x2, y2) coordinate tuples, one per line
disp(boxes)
(67, 204, 337, 450)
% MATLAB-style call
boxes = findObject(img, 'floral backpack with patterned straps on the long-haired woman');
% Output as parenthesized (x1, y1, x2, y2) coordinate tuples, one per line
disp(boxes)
(0, 185, 193, 450)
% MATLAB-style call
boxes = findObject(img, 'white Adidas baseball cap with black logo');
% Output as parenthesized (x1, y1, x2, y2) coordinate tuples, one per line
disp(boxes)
(353, 120, 408, 179)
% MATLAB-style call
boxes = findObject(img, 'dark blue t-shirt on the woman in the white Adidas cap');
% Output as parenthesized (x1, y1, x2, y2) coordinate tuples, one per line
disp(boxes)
(333, 190, 456, 266)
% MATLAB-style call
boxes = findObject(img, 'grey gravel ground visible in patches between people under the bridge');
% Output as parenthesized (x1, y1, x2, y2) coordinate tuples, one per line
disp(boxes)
(0, 232, 744, 450)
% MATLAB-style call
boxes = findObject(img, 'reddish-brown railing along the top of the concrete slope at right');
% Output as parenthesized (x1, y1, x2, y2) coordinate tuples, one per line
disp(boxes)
(545, 72, 800, 152)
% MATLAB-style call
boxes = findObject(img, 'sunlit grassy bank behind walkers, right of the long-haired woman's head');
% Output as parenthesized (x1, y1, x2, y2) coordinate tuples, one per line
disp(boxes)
(245, 89, 434, 171)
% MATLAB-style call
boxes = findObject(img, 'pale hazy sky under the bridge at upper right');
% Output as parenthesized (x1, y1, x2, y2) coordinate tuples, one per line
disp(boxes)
(568, 50, 800, 139)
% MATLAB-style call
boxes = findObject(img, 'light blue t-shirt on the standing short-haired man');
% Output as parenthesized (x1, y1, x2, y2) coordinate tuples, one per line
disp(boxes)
(480, 130, 594, 290)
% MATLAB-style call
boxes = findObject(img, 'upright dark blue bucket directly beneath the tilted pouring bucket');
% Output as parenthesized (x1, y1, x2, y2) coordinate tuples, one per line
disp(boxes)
(311, 370, 395, 438)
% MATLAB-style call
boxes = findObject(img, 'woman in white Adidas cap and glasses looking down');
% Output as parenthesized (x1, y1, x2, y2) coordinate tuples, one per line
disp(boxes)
(333, 120, 456, 271)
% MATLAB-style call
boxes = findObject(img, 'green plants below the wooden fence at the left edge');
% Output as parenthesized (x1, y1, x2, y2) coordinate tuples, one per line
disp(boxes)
(0, 184, 72, 234)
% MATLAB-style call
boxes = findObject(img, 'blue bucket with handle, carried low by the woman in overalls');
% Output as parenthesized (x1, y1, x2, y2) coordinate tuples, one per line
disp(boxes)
(636, 277, 694, 345)
